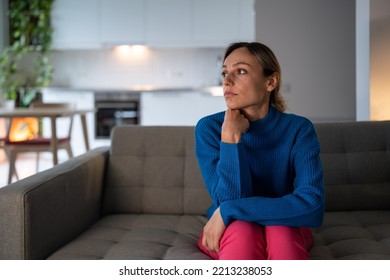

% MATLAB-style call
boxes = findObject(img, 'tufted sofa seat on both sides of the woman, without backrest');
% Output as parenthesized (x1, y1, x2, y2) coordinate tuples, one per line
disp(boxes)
(49, 211, 390, 260)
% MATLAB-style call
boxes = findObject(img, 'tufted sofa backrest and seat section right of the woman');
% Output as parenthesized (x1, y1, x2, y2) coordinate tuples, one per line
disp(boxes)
(310, 121, 390, 259)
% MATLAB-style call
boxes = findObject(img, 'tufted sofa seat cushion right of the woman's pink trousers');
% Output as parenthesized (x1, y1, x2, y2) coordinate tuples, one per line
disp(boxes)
(310, 211, 390, 260)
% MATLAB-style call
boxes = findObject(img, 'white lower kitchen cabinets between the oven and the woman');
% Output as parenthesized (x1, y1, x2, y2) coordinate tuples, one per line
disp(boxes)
(140, 91, 226, 125)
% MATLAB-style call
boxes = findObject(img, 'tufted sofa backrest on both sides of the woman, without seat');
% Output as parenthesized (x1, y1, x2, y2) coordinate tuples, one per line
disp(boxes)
(103, 121, 390, 214)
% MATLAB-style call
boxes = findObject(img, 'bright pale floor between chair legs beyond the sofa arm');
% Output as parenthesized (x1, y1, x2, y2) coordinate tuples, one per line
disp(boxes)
(0, 151, 61, 188)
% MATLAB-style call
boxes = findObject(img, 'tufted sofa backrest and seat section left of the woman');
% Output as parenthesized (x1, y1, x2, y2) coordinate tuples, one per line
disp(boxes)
(46, 127, 210, 259)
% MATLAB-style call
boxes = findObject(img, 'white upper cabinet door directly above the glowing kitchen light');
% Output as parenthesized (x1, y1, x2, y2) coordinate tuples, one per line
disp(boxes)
(99, 0, 146, 46)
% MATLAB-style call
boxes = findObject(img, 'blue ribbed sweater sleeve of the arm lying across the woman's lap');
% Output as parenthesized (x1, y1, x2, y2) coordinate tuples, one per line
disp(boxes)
(220, 123, 324, 227)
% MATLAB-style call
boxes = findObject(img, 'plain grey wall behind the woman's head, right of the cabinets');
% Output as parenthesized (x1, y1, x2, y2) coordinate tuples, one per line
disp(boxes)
(256, 0, 356, 121)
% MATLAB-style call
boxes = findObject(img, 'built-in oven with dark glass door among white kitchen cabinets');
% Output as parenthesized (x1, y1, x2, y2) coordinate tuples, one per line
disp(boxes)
(95, 91, 140, 139)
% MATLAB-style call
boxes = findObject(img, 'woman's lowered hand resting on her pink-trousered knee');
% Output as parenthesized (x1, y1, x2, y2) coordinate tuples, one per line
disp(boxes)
(202, 207, 226, 253)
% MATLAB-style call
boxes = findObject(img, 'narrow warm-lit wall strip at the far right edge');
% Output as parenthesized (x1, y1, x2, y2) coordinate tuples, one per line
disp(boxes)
(370, 0, 390, 120)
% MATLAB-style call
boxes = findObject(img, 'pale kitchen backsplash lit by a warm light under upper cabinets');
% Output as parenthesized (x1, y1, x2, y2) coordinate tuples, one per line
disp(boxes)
(48, 47, 224, 88)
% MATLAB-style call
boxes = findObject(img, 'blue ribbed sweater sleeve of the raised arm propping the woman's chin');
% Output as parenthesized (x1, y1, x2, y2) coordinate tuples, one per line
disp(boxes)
(195, 118, 252, 207)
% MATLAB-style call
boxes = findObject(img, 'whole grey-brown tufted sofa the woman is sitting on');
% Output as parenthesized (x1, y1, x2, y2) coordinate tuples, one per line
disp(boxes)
(0, 122, 390, 259)
